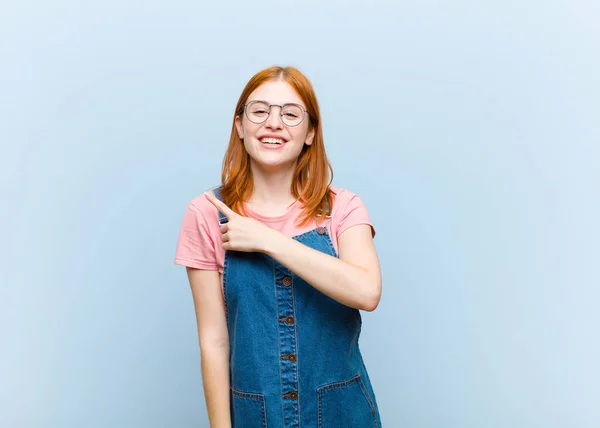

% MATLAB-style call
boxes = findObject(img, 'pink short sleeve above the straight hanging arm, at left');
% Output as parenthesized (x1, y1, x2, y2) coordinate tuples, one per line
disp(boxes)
(175, 203, 219, 270)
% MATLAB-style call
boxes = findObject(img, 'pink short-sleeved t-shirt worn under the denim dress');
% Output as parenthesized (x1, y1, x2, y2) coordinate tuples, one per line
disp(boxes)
(175, 187, 375, 274)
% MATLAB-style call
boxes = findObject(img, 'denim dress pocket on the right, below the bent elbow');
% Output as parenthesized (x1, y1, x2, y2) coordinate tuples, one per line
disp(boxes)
(317, 375, 377, 428)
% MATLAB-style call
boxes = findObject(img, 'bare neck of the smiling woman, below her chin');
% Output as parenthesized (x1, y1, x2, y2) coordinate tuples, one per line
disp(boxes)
(248, 164, 296, 206)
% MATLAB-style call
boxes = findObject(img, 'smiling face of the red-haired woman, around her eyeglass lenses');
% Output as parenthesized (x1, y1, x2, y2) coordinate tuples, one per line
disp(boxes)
(235, 80, 314, 169)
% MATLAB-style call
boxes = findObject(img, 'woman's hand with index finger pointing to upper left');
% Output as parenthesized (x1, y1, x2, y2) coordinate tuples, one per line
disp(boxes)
(204, 191, 278, 253)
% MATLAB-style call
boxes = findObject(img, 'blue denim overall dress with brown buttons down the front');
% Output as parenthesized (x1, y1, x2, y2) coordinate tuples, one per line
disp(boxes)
(215, 188, 381, 428)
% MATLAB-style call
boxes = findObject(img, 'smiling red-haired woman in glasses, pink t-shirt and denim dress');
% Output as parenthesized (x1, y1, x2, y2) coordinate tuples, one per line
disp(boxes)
(175, 67, 381, 428)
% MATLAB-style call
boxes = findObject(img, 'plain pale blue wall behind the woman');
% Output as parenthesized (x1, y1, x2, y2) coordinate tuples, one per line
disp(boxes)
(0, 0, 600, 428)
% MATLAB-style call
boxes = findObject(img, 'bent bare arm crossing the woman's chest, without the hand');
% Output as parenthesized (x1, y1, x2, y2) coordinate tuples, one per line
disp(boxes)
(264, 224, 381, 311)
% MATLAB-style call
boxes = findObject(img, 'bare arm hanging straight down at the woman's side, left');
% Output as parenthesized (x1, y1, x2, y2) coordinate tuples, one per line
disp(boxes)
(186, 267, 231, 428)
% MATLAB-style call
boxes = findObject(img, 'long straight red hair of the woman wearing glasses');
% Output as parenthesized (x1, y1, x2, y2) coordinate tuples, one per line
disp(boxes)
(221, 66, 333, 226)
